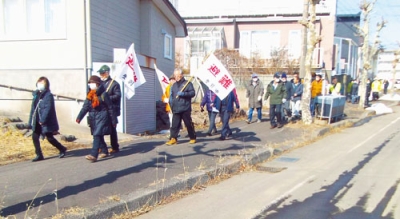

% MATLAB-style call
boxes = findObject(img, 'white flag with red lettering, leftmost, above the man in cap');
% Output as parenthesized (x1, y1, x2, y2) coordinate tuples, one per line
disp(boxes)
(116, 43, 146, 99)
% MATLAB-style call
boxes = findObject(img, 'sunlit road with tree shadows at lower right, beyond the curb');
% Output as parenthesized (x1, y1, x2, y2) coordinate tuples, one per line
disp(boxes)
(138, 106, 400, 219)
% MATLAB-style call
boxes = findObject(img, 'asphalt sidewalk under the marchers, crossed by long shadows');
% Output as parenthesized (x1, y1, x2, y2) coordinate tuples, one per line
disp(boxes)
(0, 112, 304, 218)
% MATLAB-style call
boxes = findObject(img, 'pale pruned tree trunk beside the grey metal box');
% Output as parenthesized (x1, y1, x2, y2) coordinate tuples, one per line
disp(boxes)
(300, 0, 321, 125)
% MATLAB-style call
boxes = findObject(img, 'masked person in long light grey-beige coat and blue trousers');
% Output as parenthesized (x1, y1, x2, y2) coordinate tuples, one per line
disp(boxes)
(246, 73, 264, 124)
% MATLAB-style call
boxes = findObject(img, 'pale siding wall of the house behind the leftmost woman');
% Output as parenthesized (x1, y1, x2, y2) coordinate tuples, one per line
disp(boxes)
(0, 0, 86, 117)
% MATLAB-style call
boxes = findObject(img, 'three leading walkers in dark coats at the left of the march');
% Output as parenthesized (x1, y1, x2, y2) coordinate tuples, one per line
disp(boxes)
(29, 65, 121, 162)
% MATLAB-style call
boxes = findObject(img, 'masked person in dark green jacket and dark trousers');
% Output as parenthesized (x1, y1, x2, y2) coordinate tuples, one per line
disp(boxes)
(265, 72, 287, 129)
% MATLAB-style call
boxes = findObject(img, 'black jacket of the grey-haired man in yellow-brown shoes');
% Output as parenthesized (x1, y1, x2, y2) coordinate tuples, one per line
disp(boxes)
(169, 78, 195, 113)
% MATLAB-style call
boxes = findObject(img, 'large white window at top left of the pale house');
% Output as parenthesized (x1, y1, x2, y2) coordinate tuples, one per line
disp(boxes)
(0, 0, 66, 40)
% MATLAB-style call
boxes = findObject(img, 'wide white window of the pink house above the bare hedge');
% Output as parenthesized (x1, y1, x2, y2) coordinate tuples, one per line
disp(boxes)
(239, 30, 280, 59)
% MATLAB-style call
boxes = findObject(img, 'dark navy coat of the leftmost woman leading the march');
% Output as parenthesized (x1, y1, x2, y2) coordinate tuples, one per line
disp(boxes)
(29, 90, 59, 134)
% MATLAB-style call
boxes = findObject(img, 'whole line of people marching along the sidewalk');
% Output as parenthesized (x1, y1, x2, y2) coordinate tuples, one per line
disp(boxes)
(29, 68, 378, 162)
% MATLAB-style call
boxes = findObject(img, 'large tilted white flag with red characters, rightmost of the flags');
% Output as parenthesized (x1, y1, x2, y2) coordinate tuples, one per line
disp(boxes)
(195, 54, 235, 100)
